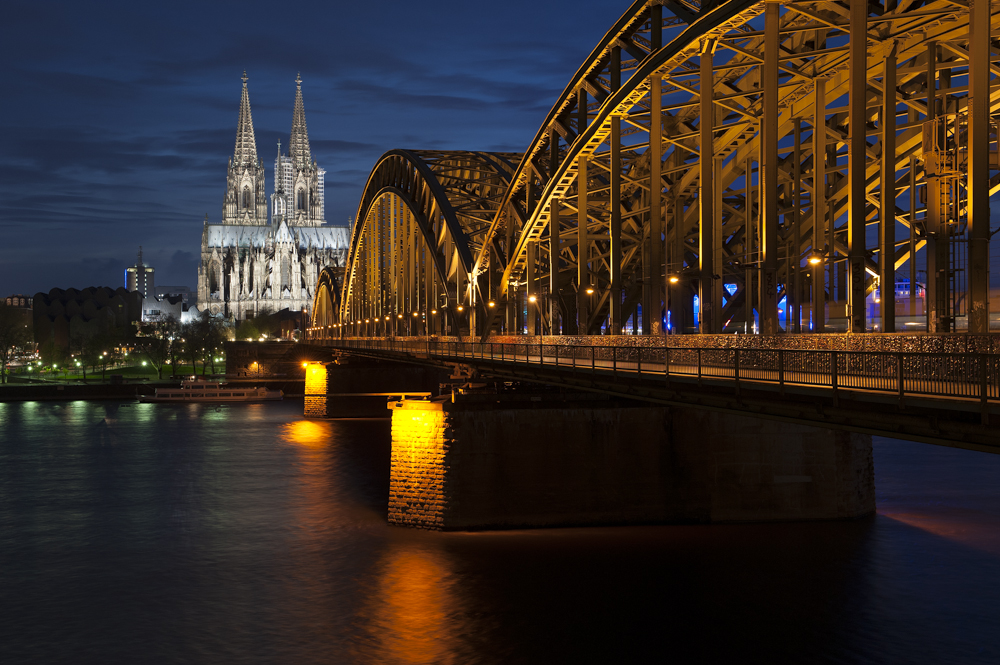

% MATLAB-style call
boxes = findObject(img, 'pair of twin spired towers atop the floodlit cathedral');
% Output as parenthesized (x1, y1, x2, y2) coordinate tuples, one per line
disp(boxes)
(222, 71, 326, 228)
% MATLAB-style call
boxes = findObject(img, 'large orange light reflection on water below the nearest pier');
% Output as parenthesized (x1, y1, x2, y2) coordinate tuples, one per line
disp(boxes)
(360, 545, 470, 663)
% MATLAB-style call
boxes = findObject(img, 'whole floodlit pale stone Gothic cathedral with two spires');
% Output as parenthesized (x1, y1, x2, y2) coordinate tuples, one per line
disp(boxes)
(197, 72, 350, 321)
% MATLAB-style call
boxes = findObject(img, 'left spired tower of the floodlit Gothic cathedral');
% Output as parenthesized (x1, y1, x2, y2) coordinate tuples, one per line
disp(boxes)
(222, 71, 267, 225)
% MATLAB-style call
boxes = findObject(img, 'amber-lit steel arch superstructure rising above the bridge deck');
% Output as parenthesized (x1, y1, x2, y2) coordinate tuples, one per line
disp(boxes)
(314, 0, 1000, 336)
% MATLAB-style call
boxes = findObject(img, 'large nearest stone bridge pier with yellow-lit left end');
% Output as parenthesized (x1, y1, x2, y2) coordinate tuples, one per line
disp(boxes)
(389, 395, 875, 530)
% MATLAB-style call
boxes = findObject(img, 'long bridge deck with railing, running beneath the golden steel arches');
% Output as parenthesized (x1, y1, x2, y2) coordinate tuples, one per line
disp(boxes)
(306, 338, 1000, 452)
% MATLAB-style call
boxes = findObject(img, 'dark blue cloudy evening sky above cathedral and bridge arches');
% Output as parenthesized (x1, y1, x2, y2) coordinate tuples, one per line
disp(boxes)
(0, 0, 631, 295)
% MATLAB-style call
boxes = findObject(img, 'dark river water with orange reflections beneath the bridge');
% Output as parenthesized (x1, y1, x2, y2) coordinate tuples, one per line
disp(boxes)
(0, 400, 1000, 664)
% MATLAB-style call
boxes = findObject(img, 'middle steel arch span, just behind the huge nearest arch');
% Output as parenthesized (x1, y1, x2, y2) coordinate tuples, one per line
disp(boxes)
(334, 150, 521, 336)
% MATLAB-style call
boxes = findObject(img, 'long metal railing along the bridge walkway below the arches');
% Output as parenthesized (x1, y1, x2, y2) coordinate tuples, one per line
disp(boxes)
(334, 338, 1000, 404)
